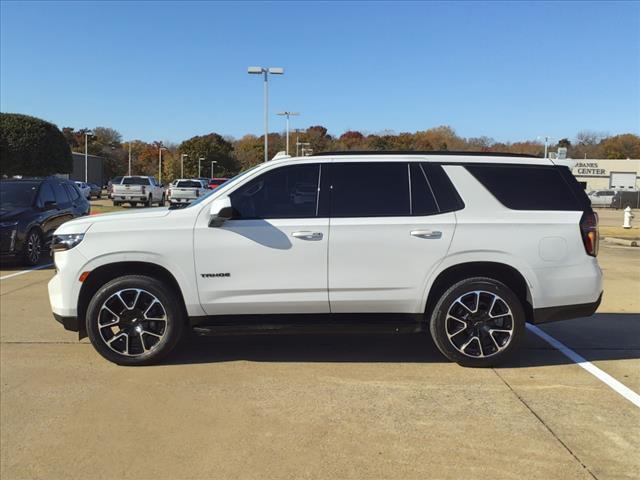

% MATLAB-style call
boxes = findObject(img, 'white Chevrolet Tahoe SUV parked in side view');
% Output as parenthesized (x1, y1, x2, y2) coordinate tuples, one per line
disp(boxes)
(49, 152, 602, 366)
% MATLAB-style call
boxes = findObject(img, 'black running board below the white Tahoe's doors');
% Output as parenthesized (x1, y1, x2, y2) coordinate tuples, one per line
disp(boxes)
(190, 313, 424, 336)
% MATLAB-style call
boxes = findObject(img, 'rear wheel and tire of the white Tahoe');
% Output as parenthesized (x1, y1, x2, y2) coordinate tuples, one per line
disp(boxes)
(429, 277, 525, 367)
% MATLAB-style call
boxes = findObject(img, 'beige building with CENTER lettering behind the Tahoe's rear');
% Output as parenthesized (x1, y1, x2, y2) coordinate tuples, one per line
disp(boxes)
(571, 159, 640, 191)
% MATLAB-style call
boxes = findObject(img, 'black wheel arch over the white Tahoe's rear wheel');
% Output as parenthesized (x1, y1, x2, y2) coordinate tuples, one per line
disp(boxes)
(424, 261, 533, 321)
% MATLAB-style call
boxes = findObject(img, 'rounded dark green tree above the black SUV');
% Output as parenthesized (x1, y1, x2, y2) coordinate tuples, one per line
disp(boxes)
(0, 113, 73, 176)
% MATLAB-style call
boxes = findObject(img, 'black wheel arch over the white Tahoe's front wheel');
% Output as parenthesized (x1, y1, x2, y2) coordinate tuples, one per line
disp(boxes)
(78, 261, 188, 338)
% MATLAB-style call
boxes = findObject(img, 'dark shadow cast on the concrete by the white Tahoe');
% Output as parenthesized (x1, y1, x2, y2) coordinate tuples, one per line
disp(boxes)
(166, 314, 640, 368)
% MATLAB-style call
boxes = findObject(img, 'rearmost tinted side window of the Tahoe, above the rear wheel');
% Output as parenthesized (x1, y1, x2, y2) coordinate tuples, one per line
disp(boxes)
(466, 165, 586, 210)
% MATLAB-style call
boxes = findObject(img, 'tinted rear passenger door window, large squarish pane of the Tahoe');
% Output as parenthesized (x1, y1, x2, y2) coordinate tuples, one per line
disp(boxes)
(330, 162, 410, 217)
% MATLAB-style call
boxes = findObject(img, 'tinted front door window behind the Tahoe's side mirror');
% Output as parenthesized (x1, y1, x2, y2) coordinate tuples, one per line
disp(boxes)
(230, 164, 320, 219)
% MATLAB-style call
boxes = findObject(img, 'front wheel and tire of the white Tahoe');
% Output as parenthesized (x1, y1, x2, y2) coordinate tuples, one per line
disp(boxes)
(86, 275, 185, 366)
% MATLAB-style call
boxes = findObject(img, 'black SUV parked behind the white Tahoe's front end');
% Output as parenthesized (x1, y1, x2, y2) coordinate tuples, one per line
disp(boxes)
(0, 177, 91, 265)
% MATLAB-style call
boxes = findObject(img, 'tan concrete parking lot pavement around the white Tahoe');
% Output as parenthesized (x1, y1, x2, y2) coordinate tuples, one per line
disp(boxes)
(0, 218, 640, 479)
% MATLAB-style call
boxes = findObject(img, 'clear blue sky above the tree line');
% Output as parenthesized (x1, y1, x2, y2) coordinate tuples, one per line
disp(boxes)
(0, 1, 640, 142)
